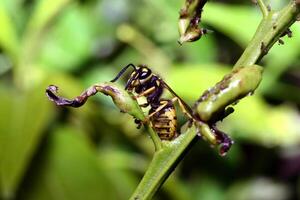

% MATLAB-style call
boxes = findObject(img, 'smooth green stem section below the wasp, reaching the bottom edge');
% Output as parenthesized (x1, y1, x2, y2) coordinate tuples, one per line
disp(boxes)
(130, 126, 196, 200)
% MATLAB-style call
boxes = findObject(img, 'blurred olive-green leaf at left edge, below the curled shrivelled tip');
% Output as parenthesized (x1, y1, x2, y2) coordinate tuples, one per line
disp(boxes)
(0, 86, 53, 197)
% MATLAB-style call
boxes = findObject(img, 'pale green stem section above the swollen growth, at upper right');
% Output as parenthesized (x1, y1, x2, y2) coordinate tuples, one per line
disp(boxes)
(234, 1, 300, 69)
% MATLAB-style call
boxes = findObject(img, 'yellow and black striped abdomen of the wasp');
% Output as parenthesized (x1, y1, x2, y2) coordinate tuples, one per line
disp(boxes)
(150, 105, 177, 140)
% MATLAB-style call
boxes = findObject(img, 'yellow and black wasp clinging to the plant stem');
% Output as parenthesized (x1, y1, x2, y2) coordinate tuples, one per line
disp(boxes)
(111, 64, 193, 140)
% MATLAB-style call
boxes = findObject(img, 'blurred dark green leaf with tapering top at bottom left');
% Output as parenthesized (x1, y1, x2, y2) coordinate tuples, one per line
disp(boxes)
(21, 127, 125, 200)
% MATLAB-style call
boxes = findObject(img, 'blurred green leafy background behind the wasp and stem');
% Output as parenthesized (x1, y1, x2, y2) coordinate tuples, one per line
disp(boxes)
(0, 0, 300, 200)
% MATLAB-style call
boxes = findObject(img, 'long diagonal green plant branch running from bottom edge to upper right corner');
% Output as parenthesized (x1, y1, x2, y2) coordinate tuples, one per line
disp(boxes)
(131, 0, 300, 200)
